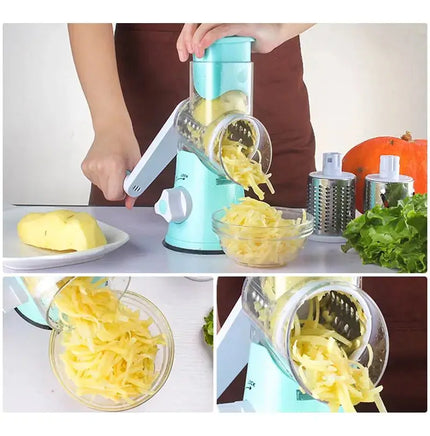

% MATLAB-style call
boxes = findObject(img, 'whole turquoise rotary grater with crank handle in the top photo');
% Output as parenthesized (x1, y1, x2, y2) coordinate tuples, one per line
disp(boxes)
(124, 37, 272, 254)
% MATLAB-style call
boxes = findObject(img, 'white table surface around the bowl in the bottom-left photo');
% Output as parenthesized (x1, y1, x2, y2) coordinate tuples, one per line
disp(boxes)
(3, 277, 214, 412)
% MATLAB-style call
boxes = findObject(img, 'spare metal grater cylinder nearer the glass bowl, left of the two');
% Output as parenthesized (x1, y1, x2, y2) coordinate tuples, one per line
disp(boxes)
(307, 153, 355, 242)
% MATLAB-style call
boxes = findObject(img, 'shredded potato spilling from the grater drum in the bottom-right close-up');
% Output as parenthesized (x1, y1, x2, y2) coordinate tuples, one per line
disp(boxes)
(291, 299, 386, 412)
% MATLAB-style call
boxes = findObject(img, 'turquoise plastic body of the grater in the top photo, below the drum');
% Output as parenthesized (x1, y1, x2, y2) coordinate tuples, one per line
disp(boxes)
(165, 150, 244, 253)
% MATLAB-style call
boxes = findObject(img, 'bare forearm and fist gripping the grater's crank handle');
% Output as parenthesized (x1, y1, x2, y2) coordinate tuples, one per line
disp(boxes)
(68, 23, 140, 209)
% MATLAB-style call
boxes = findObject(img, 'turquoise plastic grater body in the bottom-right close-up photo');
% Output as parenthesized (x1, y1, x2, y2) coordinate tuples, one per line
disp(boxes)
(243, 342, 330, 412)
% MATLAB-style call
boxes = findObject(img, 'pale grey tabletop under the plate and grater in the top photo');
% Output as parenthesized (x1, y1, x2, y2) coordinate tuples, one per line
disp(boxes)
(4, 206, 393, 275)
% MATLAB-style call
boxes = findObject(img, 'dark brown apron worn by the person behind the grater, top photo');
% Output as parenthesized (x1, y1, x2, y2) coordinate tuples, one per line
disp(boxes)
(90, 24, 315, 207)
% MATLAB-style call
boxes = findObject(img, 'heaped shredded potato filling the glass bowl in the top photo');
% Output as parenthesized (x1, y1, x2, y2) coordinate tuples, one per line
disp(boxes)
(220, 197, 306, 266)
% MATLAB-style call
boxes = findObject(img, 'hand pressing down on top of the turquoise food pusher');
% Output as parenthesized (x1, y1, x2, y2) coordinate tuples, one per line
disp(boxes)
(176, 23, 312, 62)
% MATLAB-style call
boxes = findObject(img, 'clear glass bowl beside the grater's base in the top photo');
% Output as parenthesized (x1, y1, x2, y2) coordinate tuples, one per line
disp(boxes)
(212, 207, 313, 268)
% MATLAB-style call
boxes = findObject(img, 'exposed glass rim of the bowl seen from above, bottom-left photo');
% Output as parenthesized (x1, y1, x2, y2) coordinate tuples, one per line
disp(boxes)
(49, 291, 175, 412)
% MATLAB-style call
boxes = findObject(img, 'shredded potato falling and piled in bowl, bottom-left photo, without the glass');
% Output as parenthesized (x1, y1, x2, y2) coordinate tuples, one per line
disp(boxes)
(55, 278, 165, 402)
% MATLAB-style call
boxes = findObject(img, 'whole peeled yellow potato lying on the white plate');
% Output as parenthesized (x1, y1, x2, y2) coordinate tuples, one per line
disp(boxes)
(17, 209, 107, 251)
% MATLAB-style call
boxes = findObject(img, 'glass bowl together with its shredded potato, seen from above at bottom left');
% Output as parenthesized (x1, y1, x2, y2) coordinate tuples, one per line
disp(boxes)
(50, 278, 173, 410)
